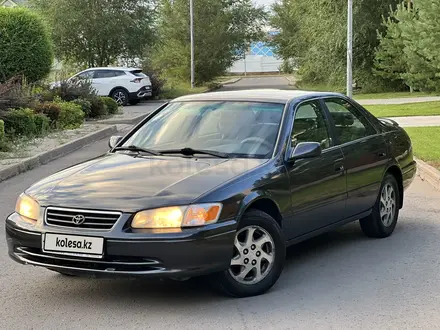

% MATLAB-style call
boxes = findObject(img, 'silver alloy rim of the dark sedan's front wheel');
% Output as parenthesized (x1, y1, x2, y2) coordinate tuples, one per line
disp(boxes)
(229, 226, 275, 284)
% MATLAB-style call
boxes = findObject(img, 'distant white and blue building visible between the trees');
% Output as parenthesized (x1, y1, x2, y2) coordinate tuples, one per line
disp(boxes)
(229, 31, 283, 74)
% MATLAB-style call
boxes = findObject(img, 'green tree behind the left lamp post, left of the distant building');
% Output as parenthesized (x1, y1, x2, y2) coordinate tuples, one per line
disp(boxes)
(151, 0, 266, 84)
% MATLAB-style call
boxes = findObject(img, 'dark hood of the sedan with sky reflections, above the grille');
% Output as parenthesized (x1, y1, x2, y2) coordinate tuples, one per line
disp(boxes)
(26, 153, 265, 212)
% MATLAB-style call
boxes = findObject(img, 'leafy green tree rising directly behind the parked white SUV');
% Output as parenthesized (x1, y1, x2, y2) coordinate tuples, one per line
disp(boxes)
(31, 0, 155, 67)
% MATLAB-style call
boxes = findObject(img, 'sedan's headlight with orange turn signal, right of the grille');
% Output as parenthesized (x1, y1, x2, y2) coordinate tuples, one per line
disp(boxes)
(131, 204, 222, 229)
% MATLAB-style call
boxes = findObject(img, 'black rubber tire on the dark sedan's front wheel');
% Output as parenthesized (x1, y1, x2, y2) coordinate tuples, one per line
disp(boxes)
(211, 210, 286, 297)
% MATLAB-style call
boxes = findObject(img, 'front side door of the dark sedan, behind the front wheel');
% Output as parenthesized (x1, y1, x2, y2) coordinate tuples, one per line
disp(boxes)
(286, 100, 347, 239)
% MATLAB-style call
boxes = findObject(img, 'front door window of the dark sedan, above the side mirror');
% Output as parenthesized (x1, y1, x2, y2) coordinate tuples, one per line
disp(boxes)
(291, 102, 333, 150)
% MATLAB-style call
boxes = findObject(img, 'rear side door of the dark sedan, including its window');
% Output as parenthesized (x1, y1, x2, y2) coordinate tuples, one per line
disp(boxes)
(323, 97, 387, 217)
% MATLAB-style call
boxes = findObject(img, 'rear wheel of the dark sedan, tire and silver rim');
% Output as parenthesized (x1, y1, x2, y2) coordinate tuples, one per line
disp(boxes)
(359, 174, 400, 238)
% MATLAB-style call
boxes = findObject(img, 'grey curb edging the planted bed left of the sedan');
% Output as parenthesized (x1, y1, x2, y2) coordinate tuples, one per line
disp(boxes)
(0, 126, 117, 182)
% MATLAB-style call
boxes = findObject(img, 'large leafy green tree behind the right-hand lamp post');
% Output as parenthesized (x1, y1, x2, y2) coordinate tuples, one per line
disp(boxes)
(271, 0, 399, 90)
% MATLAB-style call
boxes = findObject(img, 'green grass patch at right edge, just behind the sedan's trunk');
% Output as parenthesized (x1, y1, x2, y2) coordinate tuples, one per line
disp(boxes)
(405, 126, 440, 169)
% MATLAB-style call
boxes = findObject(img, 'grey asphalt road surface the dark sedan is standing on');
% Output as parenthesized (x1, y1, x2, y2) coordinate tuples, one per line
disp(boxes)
(0, 76, 440, 330)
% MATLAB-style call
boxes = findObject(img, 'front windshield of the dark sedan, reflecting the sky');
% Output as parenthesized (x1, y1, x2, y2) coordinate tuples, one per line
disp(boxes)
(123, 101, 284, 158)
